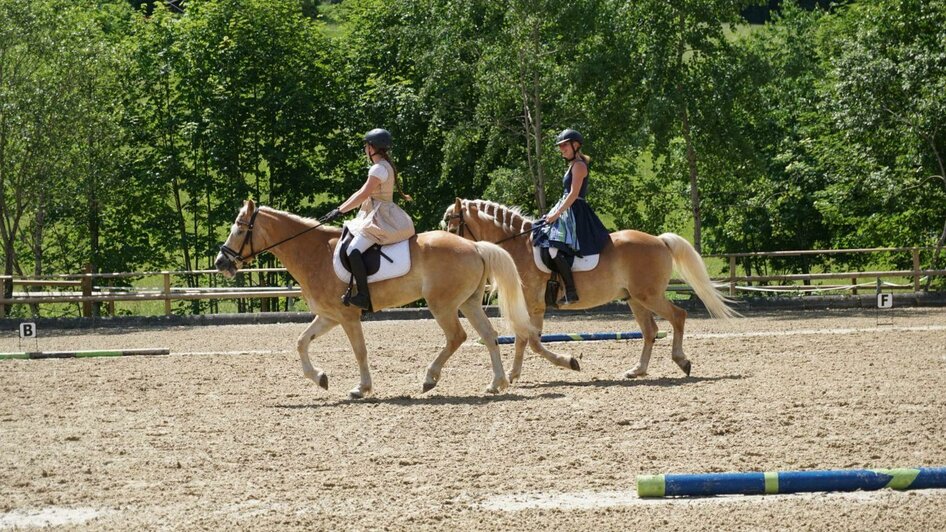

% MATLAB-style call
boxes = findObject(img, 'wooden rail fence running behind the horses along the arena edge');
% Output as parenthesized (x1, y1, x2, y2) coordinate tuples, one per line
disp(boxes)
(0, 248, 946, 318)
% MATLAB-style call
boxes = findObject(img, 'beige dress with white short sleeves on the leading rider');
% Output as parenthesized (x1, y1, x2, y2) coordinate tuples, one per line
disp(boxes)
(345, 161, 415, 246)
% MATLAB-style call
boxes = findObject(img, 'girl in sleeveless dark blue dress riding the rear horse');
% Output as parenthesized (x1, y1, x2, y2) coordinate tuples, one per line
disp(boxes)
(536, 128, 611, 306)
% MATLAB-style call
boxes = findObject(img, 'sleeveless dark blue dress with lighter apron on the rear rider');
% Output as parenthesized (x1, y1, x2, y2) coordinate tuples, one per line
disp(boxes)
(534, 160, 611, 257)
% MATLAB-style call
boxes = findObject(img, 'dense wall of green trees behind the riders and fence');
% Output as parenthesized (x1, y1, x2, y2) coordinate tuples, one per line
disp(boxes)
(0, 0, 946, 316)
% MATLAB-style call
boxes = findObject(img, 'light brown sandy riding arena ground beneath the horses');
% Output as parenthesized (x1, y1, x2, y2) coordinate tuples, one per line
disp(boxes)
(0, 309, 946, 531)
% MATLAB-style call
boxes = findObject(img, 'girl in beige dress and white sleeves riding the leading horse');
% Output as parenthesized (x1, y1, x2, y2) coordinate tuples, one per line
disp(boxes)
(323, 129, 415, 311)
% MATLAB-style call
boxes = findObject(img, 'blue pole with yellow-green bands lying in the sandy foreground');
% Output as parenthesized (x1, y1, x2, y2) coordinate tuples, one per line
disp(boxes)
(637, 467, 946, 497)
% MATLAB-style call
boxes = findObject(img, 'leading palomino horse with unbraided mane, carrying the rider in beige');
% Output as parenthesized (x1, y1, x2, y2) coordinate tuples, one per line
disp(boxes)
(215, 201, 578, 399)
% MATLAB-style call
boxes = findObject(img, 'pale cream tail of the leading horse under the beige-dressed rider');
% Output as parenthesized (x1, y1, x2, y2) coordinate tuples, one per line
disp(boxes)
(474, 242, 537, 338)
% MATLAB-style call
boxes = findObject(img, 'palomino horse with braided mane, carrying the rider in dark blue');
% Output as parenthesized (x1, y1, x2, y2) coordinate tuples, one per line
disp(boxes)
(442, 198, 738, 382)
